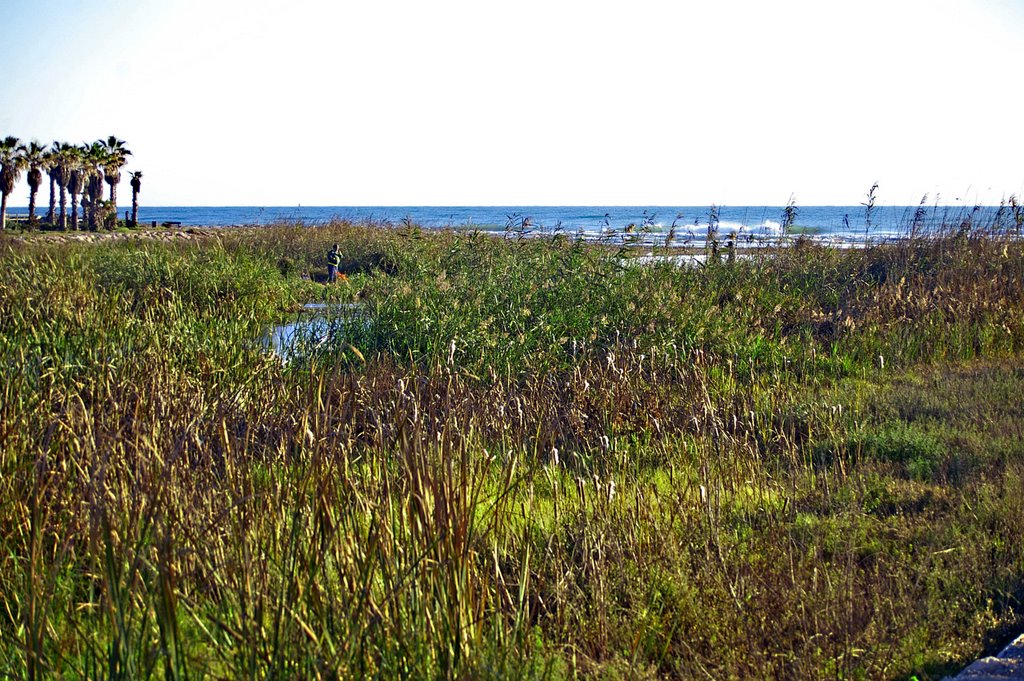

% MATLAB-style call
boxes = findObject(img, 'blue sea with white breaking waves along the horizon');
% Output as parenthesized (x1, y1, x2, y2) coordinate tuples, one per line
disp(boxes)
(10, 205, 1015, 245)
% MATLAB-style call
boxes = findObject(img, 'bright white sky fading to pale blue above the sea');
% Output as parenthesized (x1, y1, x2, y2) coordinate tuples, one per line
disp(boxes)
(0, 0, 1024, 206)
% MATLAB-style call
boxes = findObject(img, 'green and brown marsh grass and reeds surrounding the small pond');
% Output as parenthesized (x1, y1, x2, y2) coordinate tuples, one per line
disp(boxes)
(0, 223, 1024, 679)
